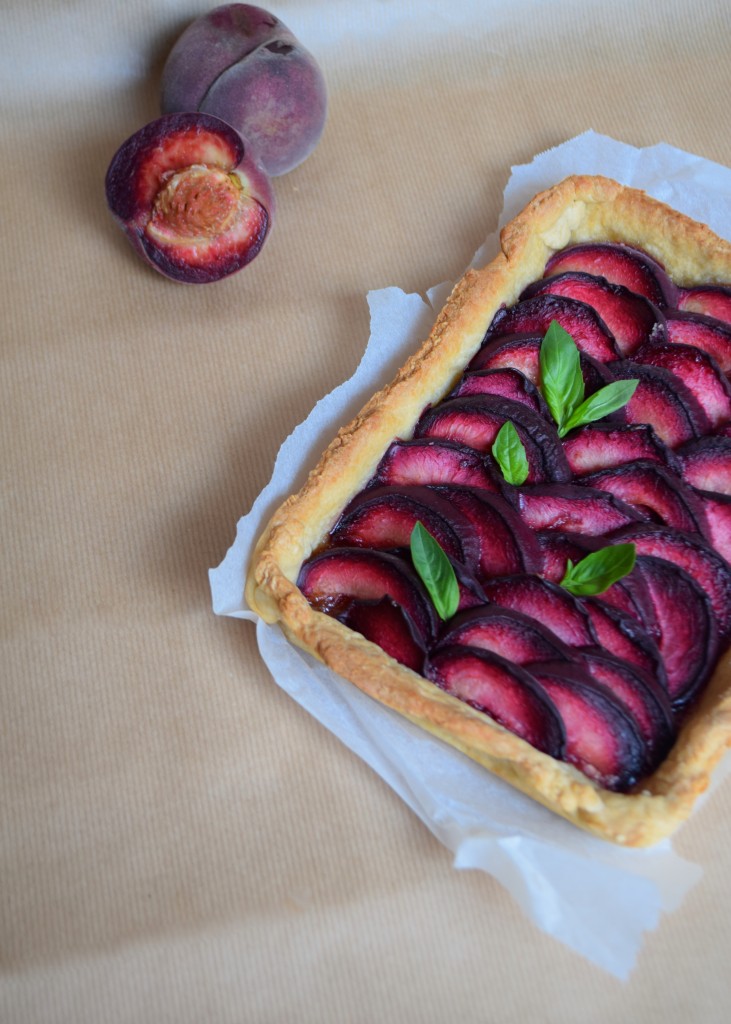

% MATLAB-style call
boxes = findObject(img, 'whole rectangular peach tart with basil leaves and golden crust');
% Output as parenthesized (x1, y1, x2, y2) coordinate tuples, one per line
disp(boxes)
(246, 176, 731, 846)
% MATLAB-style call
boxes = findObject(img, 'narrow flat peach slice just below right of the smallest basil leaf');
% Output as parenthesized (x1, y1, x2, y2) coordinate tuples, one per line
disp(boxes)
(515, 483, 645, 537)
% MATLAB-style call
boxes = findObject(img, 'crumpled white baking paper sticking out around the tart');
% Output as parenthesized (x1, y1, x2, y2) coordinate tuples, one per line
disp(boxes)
(210, 131, 731, 979)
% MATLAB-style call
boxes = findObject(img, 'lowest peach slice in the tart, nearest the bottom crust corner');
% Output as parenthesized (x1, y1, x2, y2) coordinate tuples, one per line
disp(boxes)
(530, 662, 647, 791)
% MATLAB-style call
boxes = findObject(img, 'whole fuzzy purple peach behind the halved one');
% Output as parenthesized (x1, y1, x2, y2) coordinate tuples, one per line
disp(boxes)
(162, 3, 328, 176)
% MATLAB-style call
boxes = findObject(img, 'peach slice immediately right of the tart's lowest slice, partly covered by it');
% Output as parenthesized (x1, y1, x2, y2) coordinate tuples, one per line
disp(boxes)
(581, 649, 676, 775)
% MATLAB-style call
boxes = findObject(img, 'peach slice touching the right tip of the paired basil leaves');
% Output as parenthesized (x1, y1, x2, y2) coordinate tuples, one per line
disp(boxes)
(609, 359, 710, 449)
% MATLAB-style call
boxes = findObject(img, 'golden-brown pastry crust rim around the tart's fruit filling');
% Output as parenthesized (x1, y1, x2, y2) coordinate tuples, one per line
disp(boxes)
(246, 176, 731, 847)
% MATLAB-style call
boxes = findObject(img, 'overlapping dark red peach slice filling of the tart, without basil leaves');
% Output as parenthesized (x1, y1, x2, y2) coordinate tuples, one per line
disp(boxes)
(298, 244, 731, 792)
